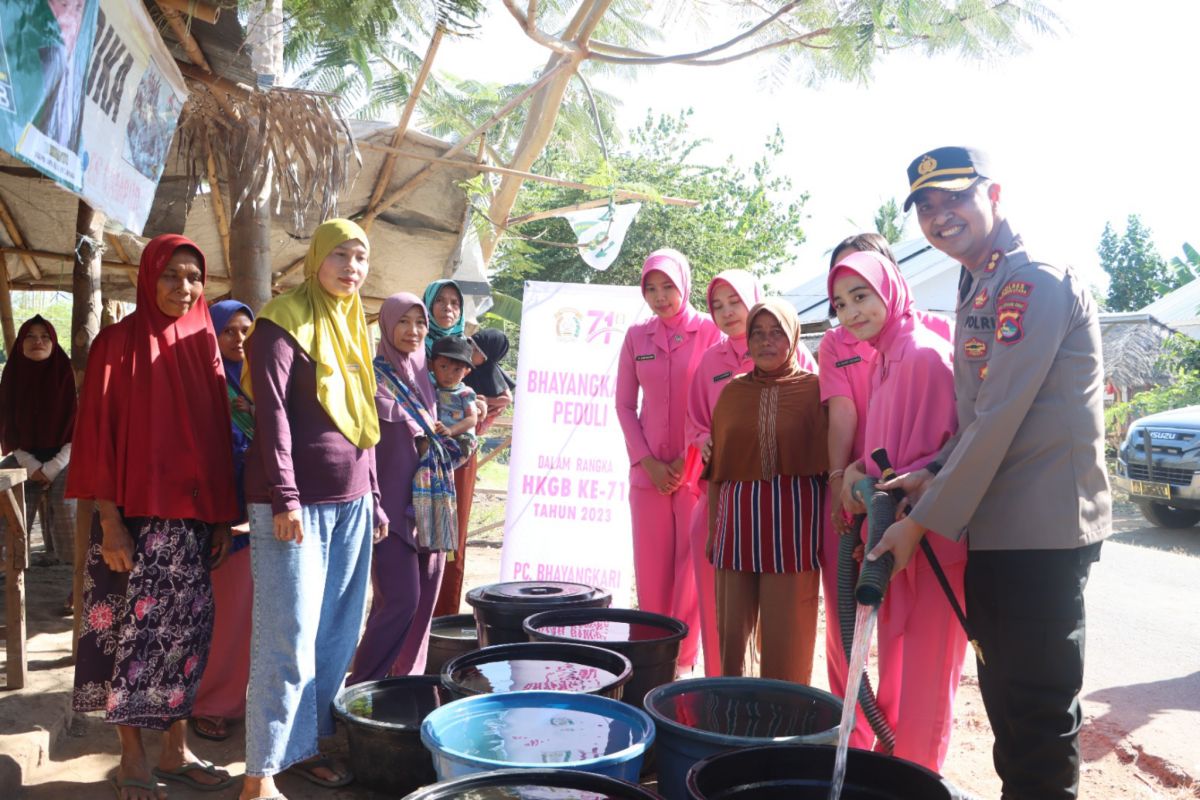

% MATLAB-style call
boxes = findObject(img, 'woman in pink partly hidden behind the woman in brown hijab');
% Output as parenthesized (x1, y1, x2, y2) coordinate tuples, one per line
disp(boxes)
(686, 270, 817, 678)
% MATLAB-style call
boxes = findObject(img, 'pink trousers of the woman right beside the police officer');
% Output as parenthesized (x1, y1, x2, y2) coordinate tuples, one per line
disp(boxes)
(876, 554, 967, 772)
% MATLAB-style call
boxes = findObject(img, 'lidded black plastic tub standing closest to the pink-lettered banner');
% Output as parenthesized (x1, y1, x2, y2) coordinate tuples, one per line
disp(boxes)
(467, 581, 612, 648)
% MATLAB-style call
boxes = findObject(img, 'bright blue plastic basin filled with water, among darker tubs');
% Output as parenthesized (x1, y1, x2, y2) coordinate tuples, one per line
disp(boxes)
(421, 691, 654, 782)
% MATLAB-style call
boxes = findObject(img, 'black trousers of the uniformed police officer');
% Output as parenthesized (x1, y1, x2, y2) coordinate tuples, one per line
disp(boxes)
(966, 542, 1100, 800)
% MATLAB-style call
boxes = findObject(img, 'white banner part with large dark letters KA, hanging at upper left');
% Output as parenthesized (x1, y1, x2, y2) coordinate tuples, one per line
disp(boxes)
(79, 0, 186, 234)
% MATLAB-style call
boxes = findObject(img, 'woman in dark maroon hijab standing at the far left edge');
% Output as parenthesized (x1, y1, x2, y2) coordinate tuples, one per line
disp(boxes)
(0, 315, 76, 564)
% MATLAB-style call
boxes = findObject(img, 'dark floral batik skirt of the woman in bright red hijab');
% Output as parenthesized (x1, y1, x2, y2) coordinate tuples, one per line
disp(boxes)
(73, 515, 214, 730)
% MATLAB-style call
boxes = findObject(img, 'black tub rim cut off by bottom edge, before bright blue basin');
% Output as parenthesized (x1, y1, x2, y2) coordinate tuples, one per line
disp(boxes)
(404, 770, 662, 800)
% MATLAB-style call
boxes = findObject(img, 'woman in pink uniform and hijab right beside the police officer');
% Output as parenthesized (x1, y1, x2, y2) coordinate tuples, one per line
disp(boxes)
(828, 252, 967, 771)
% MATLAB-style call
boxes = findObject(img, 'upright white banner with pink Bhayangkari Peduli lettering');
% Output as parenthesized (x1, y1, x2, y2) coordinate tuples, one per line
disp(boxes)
(500, 281, 649, 606)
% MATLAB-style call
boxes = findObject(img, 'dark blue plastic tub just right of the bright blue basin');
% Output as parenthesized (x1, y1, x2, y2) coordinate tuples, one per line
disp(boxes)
(646, 678, 841, 800)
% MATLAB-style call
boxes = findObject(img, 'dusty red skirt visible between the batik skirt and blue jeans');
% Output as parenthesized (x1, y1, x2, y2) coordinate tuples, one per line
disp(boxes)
(192, 547, 254, 720)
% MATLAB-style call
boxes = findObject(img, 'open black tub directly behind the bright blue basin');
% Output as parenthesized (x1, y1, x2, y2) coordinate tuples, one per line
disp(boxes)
(442, 642, 634, 700)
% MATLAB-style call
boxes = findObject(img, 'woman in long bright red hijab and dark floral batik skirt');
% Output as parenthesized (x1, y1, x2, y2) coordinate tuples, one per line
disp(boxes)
(67, 234, 238, 800)
